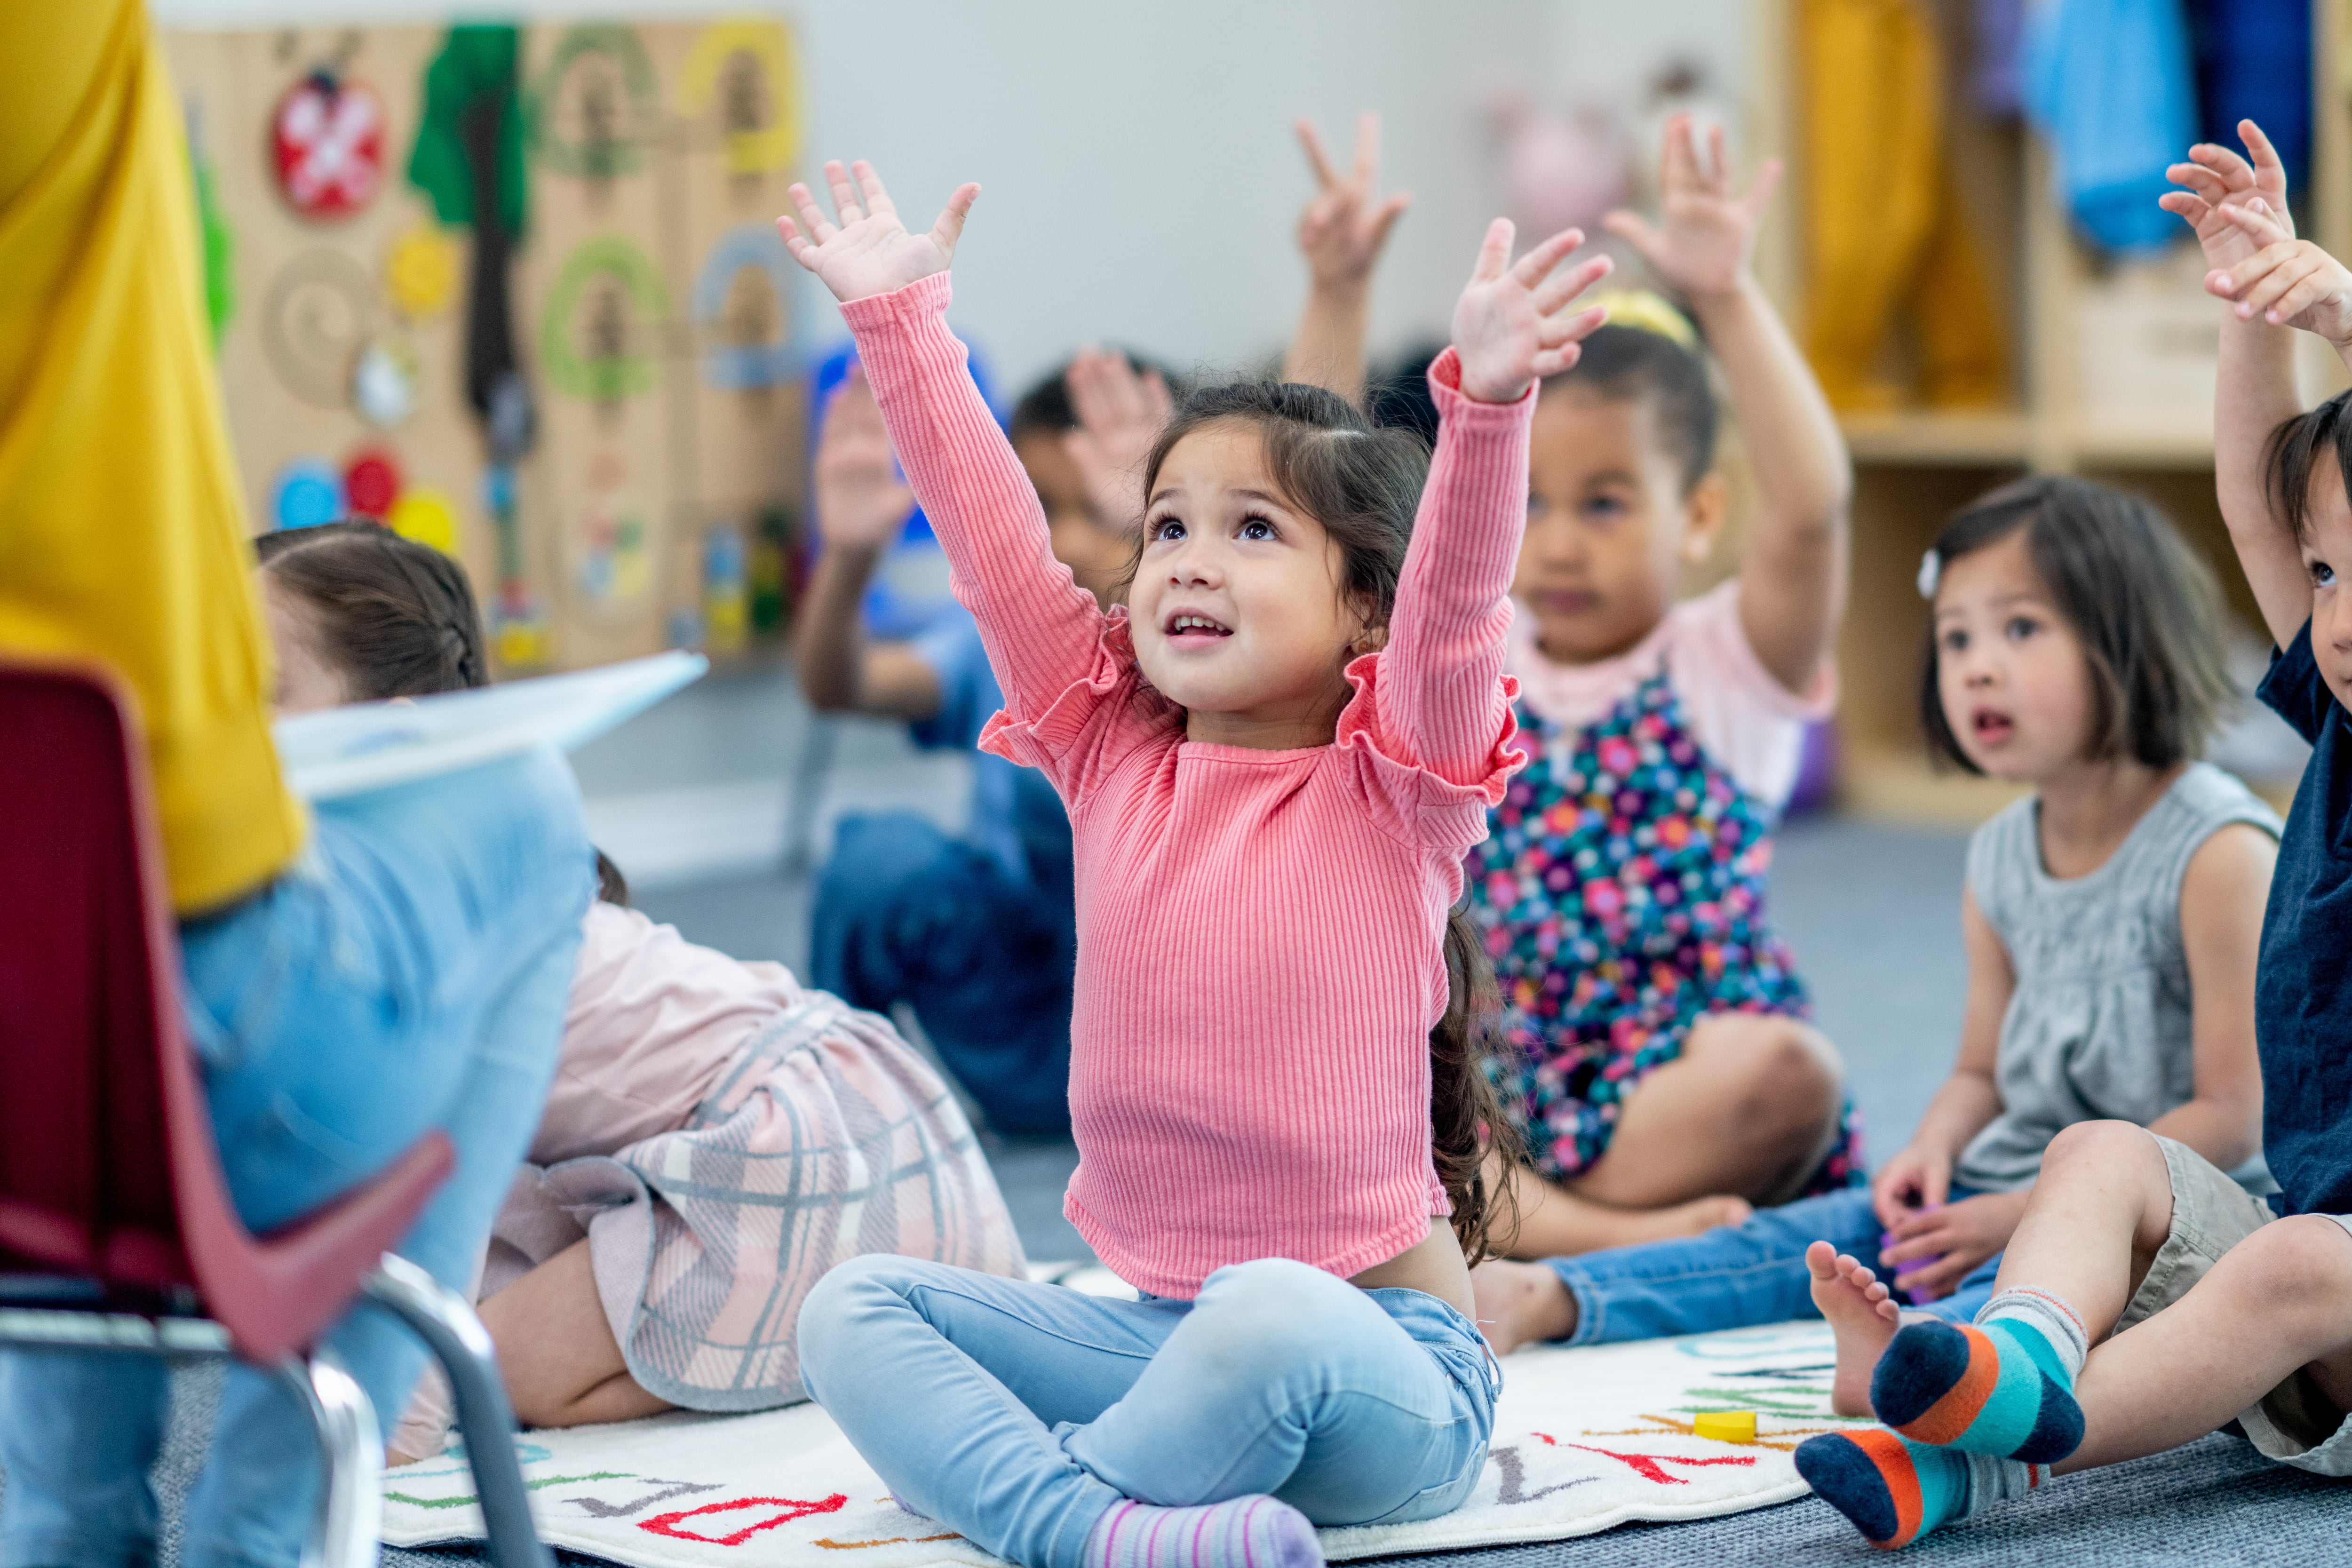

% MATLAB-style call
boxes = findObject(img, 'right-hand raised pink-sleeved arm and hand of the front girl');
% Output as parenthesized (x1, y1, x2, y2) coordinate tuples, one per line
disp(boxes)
(1374, 219, 1611, 785)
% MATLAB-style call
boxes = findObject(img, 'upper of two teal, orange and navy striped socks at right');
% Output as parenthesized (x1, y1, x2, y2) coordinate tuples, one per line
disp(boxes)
(1870, 1290, 2089, 1465)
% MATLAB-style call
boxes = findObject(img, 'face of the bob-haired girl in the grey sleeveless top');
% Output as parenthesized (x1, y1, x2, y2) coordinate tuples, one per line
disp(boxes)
(1936, 529, 2093, 783)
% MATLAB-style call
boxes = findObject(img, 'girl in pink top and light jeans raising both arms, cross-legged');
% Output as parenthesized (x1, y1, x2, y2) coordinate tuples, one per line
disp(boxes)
(781, 165, 1606, 1568)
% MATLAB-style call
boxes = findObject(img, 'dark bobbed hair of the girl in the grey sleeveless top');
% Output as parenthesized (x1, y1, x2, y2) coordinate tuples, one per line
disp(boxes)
(1919, 475, 2237, 773)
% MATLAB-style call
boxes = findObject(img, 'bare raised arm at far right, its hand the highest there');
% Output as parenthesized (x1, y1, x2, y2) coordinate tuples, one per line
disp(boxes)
(2161, 120, 2312, 649)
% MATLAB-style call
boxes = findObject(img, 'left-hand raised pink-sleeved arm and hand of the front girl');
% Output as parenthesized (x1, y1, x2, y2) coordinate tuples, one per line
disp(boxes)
(776, 160, 1101, 717)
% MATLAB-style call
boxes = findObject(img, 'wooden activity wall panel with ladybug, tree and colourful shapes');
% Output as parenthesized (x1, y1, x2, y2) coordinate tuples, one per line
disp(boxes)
(167, 16, 814, 668)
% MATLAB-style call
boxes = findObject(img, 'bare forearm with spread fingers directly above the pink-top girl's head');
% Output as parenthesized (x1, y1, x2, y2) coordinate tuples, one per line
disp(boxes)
(1282, 113, 1414, 404)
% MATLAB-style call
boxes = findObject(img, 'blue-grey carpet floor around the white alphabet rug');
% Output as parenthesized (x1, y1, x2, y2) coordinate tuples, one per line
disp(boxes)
(9, 820, 2352, 1568)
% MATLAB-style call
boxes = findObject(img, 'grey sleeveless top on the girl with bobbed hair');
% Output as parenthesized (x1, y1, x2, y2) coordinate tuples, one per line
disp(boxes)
(1952, 762, 2279, 1192)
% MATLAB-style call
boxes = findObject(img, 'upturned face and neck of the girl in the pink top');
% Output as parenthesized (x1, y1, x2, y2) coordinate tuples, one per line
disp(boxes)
(1127, 421, 1378, 748)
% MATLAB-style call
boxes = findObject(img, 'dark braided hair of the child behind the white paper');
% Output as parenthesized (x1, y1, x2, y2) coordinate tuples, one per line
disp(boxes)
(254, 519, 628, 905)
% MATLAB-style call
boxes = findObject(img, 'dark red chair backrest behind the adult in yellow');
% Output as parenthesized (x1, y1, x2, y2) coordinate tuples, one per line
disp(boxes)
(0, 661, 195, 1288)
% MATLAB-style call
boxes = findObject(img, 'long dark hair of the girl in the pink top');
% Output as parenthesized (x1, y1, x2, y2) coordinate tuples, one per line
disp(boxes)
(1127, 381, 1522, 1262)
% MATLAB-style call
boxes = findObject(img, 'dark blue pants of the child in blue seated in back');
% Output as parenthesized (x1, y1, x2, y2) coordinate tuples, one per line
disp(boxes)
(809, 811, 1077, 1136)
